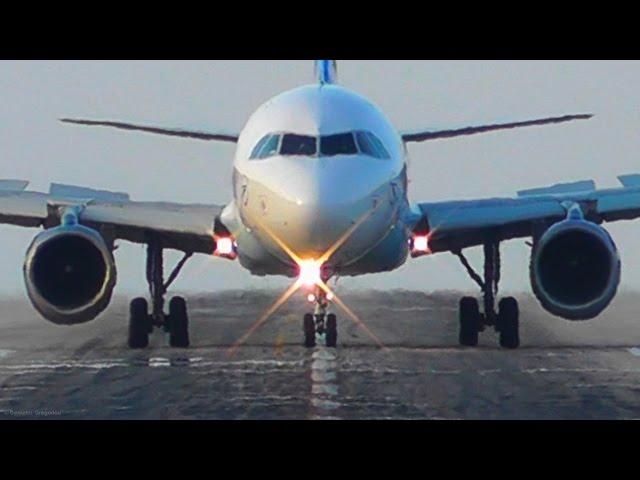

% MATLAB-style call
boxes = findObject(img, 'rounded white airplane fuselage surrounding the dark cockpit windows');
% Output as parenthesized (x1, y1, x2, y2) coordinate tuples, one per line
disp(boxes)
(222, 85, 409, 276)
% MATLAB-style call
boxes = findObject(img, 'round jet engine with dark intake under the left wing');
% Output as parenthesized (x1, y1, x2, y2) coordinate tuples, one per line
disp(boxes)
(24, 224, 116, 325)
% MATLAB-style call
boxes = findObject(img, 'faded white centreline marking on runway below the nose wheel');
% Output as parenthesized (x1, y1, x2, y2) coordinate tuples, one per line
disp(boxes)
(311, 347, 342, 420)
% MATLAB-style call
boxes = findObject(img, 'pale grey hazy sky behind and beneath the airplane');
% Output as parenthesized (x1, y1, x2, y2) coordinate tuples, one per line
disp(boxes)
(0, 60, 640, 294)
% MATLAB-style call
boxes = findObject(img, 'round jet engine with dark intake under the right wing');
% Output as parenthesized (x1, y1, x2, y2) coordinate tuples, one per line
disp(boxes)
(531, 219, 621, 320)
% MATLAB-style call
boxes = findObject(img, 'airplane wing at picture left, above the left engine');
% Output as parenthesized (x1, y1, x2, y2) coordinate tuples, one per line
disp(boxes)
(0, 180, 223, 254)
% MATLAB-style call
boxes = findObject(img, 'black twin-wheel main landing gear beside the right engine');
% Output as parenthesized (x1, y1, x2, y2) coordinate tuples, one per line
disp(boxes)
(454, 241, 520, 349)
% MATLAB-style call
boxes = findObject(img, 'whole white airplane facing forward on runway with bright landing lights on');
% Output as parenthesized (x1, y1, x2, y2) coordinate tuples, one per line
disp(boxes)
(0, 60, 640, 349)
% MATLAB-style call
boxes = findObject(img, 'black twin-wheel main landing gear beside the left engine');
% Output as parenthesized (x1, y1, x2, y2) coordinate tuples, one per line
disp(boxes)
(129, 238, 193, 349)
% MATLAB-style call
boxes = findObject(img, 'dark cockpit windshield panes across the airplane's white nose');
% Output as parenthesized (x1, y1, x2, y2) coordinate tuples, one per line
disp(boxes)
(251, 132, 391, 160)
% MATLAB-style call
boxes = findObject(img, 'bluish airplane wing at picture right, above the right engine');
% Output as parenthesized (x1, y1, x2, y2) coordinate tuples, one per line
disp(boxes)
(414, 175, 640, 253)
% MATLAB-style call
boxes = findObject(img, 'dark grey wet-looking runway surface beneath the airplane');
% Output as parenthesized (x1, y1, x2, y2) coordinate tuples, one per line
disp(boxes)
(0, 292, 640, 420)
